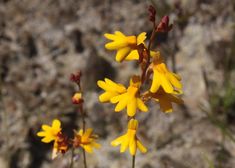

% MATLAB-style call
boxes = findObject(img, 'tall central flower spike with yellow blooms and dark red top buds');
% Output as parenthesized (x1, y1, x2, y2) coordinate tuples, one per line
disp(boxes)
(97, 6, 183, 156)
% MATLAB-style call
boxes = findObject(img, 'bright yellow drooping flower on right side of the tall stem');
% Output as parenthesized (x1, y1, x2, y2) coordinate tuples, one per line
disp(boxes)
(150, 53, 182, 93)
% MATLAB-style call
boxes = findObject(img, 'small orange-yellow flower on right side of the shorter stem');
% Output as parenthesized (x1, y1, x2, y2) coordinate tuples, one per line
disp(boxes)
(73, 128, 101, 153)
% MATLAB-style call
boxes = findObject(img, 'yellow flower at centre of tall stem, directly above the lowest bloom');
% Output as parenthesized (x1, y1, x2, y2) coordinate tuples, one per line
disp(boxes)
(111, 76, 148, 117)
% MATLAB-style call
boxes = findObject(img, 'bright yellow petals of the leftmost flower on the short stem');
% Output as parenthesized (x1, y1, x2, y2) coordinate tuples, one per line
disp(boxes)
(37, 119, 61, 143)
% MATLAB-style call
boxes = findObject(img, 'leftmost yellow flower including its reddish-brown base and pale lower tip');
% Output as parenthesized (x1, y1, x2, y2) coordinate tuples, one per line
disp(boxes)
(37, 119, 68, 159)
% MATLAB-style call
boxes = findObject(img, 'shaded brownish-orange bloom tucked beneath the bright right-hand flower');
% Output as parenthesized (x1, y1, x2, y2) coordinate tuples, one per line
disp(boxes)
(149, 87, 184, 113)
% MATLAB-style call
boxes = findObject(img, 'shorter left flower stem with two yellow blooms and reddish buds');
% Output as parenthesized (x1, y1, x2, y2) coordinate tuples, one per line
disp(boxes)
(37, 71, 100, 164)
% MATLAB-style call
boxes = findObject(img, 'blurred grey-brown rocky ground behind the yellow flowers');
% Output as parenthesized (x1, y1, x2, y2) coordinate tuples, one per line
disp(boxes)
(0, 0, 235, 168)
